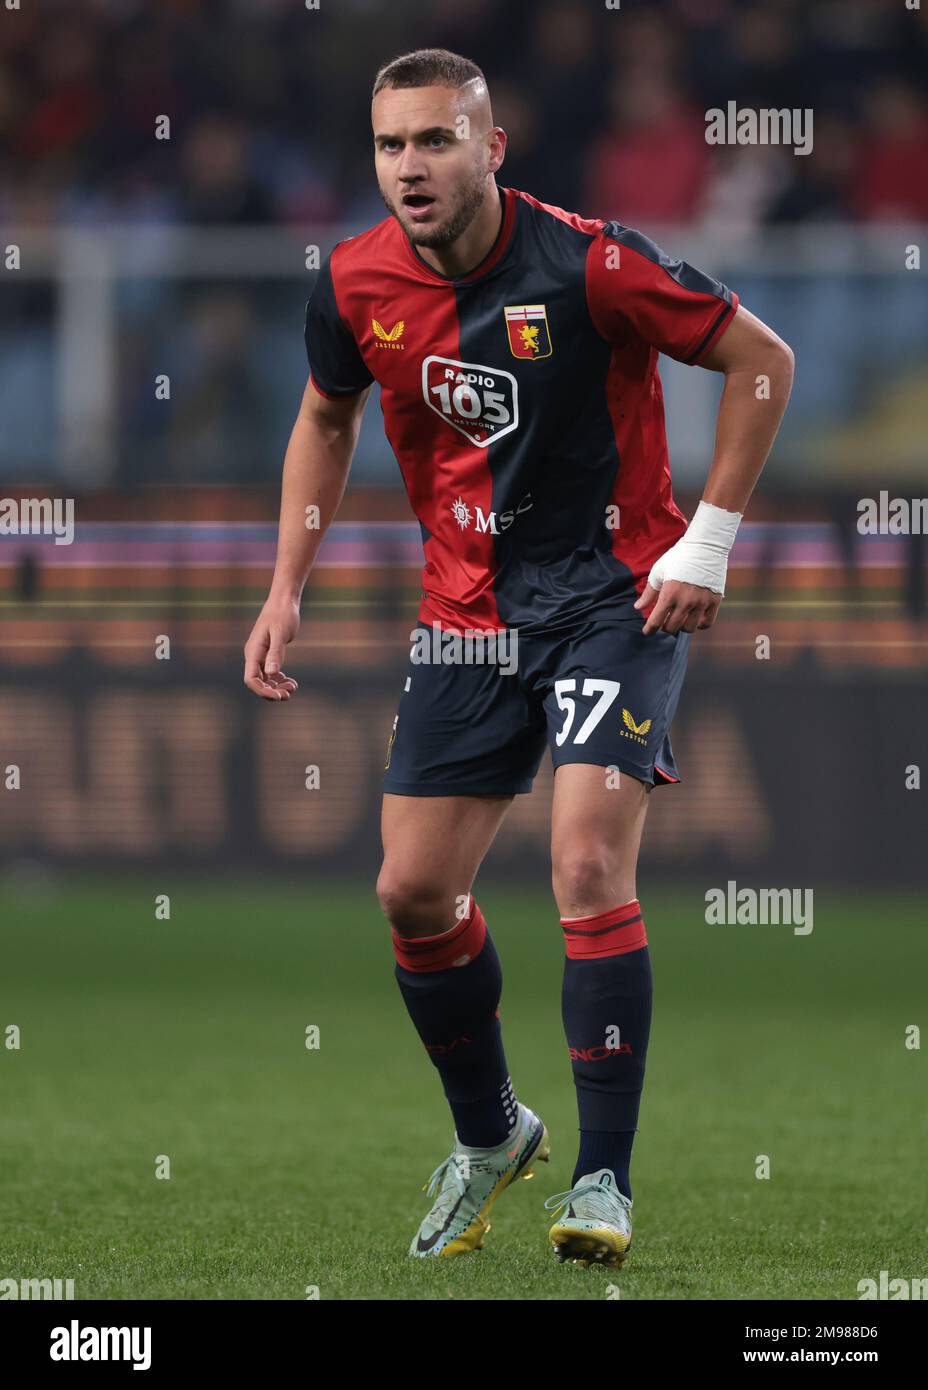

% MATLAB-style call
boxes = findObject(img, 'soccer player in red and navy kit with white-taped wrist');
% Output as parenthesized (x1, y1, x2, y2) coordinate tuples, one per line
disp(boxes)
(245, 49, 793, 1265)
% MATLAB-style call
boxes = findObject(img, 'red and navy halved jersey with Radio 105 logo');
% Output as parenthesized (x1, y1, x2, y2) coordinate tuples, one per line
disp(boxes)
(306, 188, 738, 632)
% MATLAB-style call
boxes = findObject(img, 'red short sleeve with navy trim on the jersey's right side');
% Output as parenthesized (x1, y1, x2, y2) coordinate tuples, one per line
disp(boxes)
(586, 222, 738, 363)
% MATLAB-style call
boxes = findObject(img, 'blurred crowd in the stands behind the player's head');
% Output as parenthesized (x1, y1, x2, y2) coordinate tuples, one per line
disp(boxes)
(0, 0, 928, 225)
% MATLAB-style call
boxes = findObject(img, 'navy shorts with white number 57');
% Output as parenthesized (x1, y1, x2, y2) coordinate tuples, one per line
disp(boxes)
(383, 605, 690, 796)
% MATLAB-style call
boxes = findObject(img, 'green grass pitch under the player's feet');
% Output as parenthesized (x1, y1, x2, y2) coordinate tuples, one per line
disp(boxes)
(0, 874, 928, 1300)
